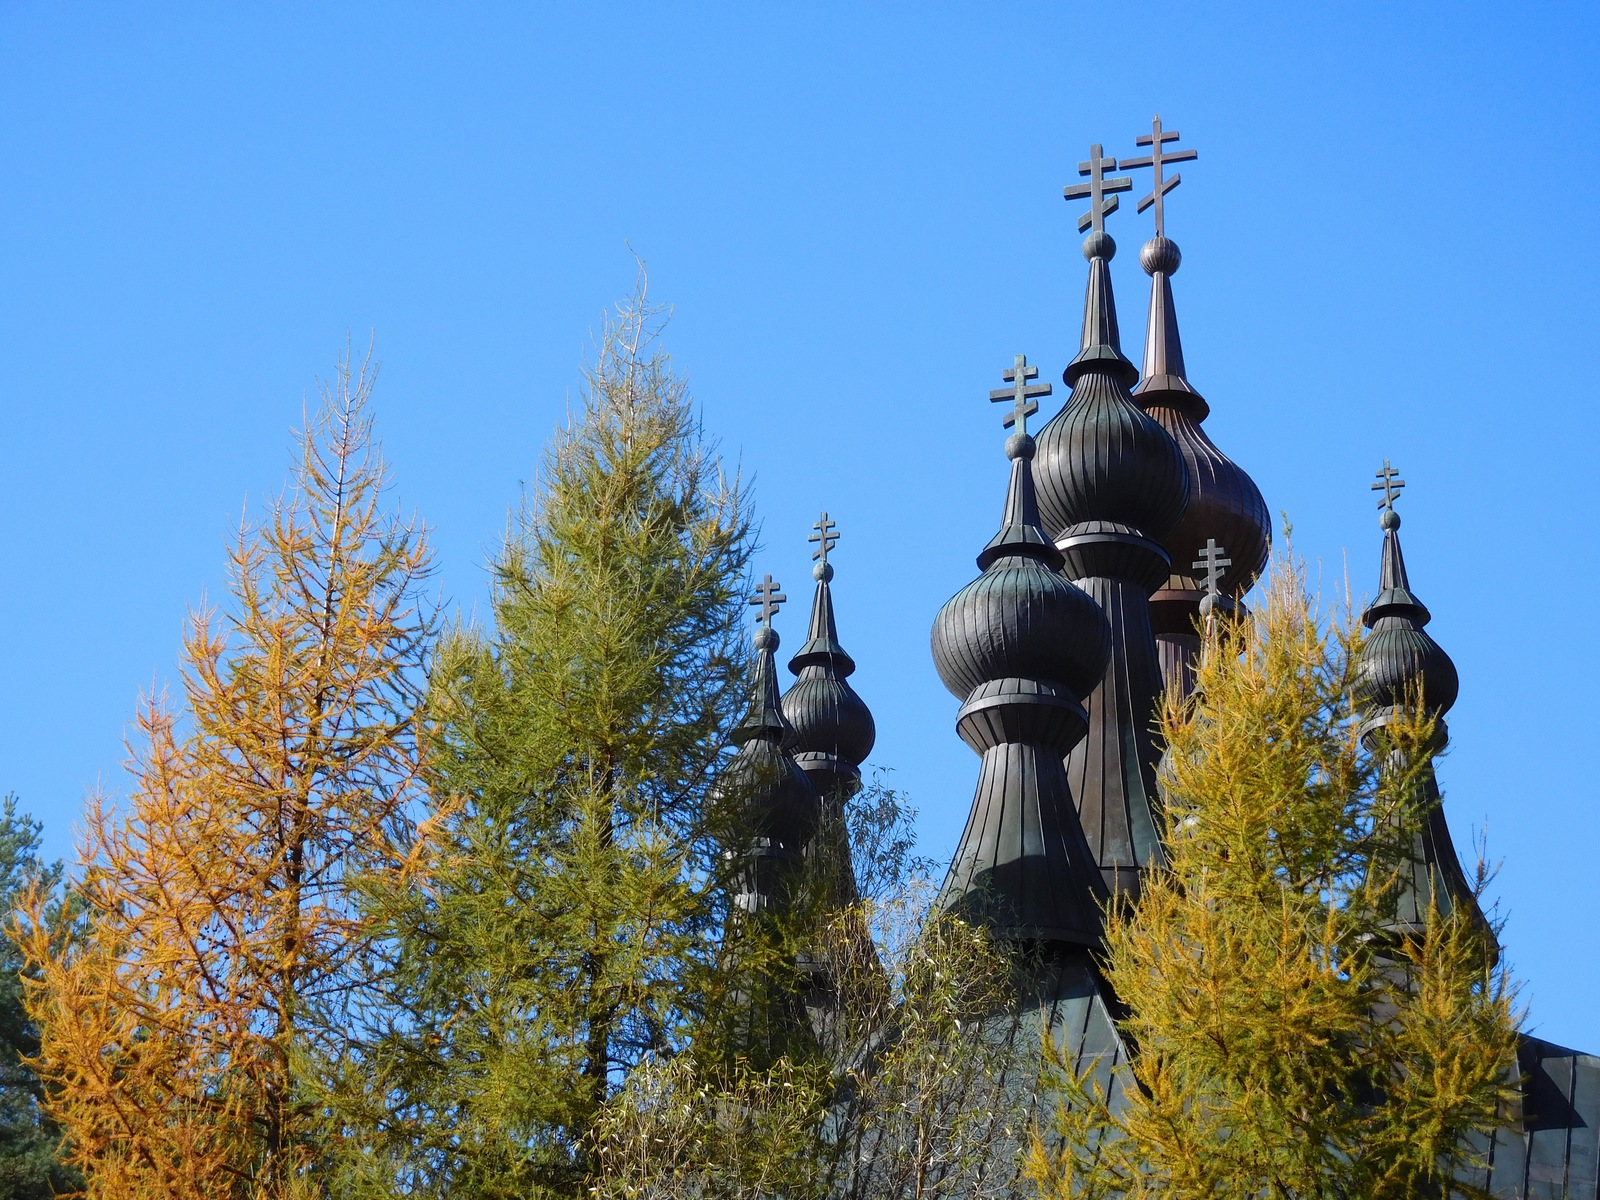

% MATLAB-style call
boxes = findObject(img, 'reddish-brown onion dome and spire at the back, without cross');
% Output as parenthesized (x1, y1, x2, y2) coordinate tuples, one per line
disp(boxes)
(1133, 237, 1272, 603)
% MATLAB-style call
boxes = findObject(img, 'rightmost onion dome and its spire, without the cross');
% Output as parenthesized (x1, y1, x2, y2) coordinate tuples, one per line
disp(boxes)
(1357, 509, 1461, 717)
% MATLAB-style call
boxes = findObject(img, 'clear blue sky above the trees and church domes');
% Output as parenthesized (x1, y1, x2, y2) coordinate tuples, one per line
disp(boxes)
(0, 0, 1600, 1050)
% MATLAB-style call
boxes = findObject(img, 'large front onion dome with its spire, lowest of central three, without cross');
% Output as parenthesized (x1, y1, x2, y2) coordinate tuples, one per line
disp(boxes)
(933, 434, 1110, 701)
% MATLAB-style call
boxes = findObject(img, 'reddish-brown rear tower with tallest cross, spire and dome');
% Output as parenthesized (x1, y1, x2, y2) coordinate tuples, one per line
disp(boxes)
(1122, 115, 1272, 694)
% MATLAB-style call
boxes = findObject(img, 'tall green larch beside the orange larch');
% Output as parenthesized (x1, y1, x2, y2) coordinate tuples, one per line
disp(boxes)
(331, 277, 752, 1197)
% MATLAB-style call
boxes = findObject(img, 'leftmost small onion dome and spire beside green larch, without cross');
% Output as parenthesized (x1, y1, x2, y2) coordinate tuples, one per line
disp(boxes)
(717, 626, 819, 858)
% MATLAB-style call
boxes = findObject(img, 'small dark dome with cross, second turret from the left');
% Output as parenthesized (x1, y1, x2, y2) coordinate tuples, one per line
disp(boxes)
(782, 512, 877, 798)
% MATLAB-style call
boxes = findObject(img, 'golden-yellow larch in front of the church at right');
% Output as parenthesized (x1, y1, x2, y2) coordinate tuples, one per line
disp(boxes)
(1030, 563, 1515, 1200)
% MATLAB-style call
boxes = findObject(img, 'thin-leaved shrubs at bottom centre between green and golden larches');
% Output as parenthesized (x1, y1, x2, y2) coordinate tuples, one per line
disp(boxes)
(597, 787, 1037, 1200)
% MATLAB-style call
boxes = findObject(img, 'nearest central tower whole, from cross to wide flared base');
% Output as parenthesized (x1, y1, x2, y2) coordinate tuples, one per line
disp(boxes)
(933, 355, 1110, 946)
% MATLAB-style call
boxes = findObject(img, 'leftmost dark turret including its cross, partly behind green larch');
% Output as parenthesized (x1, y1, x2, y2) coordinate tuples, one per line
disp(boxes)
(729, 576, 821, 912)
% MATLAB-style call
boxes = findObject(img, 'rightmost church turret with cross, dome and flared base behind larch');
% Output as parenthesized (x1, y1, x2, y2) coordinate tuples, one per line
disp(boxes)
(1357, 459, 1493, 949)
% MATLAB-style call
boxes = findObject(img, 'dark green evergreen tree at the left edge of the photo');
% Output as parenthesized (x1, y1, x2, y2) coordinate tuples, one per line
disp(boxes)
(0, 795, 82, 1200)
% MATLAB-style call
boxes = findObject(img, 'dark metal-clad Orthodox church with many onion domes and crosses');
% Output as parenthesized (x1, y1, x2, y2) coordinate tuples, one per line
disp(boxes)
(733, 118, 1600, 1200)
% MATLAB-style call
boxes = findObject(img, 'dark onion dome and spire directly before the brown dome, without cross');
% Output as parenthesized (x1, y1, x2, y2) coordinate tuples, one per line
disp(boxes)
(1037, 232, 1189, 553)
